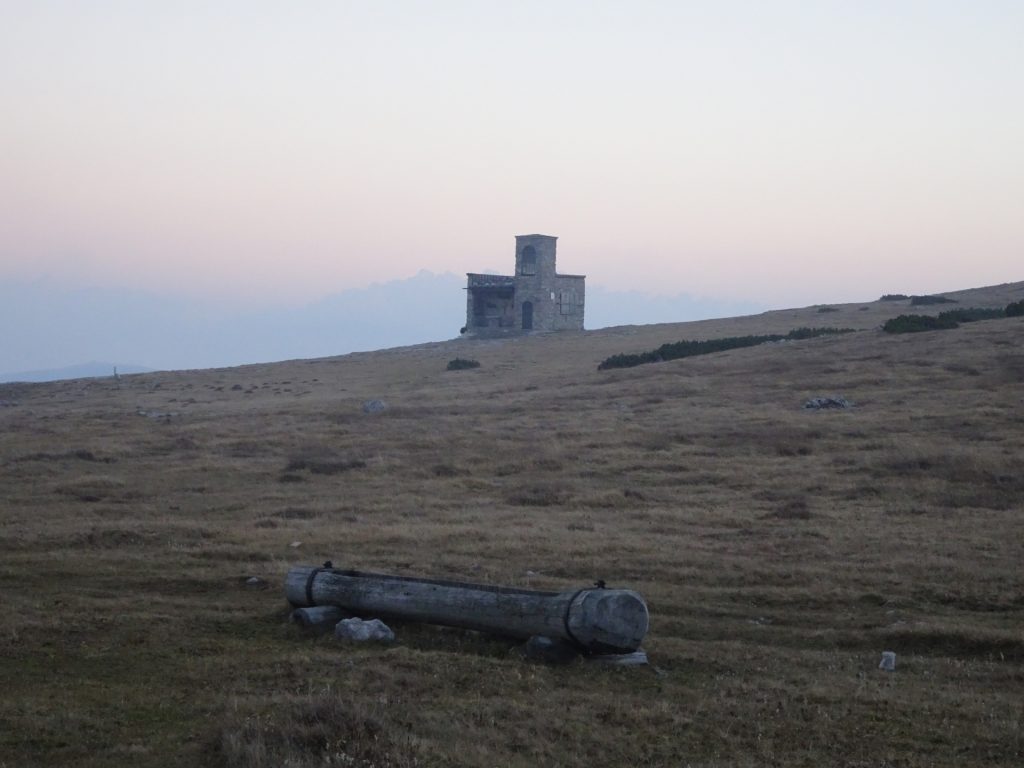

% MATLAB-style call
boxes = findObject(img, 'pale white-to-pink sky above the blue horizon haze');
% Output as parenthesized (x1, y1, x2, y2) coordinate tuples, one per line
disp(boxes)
(0, 0, 1024, 305)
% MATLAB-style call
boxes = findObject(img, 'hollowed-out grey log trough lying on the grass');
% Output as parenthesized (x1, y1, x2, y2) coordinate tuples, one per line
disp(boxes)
(285, 565, 648, 653)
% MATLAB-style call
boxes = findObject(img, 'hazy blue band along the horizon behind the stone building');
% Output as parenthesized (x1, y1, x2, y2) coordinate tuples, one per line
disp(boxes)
(0, 270, 766, 381)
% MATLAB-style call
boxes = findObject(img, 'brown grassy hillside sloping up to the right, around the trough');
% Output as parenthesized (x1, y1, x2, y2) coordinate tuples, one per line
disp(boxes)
(0, 284, 1024, 766)
